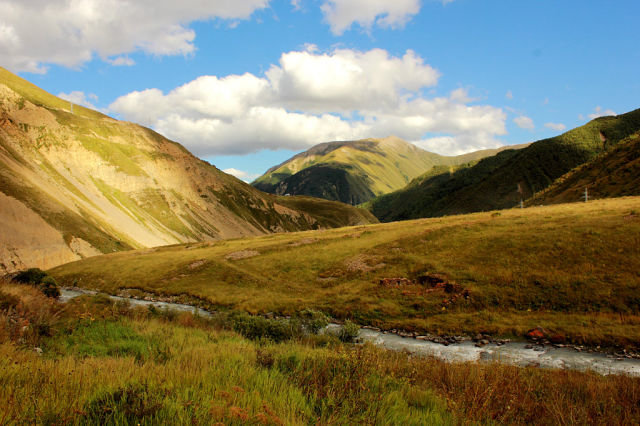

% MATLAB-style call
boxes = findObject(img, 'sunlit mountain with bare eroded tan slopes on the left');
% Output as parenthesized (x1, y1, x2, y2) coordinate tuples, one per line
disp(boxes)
(0, 68, 376, 272)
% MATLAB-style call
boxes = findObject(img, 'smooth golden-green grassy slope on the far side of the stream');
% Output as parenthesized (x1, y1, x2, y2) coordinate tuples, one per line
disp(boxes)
(50, 197, 640, 349)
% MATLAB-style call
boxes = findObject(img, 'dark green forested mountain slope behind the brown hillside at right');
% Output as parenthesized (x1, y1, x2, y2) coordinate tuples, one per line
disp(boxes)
(367, 109, 640, 222)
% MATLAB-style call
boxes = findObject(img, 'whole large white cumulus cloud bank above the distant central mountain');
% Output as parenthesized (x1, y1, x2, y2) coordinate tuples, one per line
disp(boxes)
(109, 47, 506, 156)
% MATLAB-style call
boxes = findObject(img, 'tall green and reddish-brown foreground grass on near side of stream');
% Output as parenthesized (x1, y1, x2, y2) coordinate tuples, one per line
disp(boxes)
(0, 282, 640, 425)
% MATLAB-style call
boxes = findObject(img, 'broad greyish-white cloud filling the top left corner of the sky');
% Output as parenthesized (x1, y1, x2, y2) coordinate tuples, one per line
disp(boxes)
(0, 0, 270, 73)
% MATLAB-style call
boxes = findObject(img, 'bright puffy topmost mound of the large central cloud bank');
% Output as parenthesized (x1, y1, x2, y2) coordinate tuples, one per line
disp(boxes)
(266, 45, 440, 112)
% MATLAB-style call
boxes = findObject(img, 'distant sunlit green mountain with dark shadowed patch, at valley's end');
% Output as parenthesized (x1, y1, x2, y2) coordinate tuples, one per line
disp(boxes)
(252, 137, 524, 205)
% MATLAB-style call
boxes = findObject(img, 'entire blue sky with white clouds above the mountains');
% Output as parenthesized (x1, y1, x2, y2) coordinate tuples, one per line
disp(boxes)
(0, 0, 640, 181)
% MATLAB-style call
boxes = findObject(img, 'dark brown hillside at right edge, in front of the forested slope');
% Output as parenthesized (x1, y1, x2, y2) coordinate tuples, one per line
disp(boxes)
(525, 134, 640, 206)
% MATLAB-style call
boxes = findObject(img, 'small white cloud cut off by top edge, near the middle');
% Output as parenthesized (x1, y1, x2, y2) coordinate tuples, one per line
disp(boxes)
(320, 0, 422, 35)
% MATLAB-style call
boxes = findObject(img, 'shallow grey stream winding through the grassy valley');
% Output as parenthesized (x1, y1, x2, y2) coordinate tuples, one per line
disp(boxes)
(60, 289, 640, 376)
